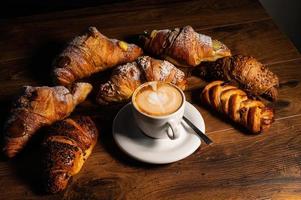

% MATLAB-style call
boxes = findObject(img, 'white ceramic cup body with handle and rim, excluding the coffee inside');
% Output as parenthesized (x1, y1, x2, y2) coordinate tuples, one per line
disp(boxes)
(132, 81, 186, 140)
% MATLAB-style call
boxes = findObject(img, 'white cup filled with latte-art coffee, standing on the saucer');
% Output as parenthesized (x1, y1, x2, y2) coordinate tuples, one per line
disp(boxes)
(132, 81, 186, 140)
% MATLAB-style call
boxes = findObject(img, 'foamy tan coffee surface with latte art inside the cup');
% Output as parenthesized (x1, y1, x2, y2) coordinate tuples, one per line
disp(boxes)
(133, 82, 183, 116)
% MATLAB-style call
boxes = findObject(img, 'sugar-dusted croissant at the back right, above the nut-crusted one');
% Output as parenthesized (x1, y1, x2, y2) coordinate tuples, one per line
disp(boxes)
(140, 26, 231, 67)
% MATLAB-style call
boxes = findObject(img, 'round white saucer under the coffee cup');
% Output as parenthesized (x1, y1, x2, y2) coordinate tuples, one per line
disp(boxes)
(113, 102, 205, 164)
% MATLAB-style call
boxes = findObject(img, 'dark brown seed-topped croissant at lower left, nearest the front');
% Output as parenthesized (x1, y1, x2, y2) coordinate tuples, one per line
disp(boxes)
(42, 116, 98, 193)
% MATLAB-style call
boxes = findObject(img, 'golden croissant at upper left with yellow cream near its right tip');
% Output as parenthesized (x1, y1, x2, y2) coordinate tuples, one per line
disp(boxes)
(53, 27, 143, 85)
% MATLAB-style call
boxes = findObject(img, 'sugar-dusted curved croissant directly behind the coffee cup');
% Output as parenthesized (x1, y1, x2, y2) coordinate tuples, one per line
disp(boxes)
(97, 56, 187, 104)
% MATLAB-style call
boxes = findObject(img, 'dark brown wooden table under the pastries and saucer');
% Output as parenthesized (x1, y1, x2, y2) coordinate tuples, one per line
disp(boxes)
(0, 0, 301, 199)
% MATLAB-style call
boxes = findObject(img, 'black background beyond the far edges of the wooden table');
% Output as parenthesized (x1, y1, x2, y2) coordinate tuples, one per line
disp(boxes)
(0, 0, 301, 52)
